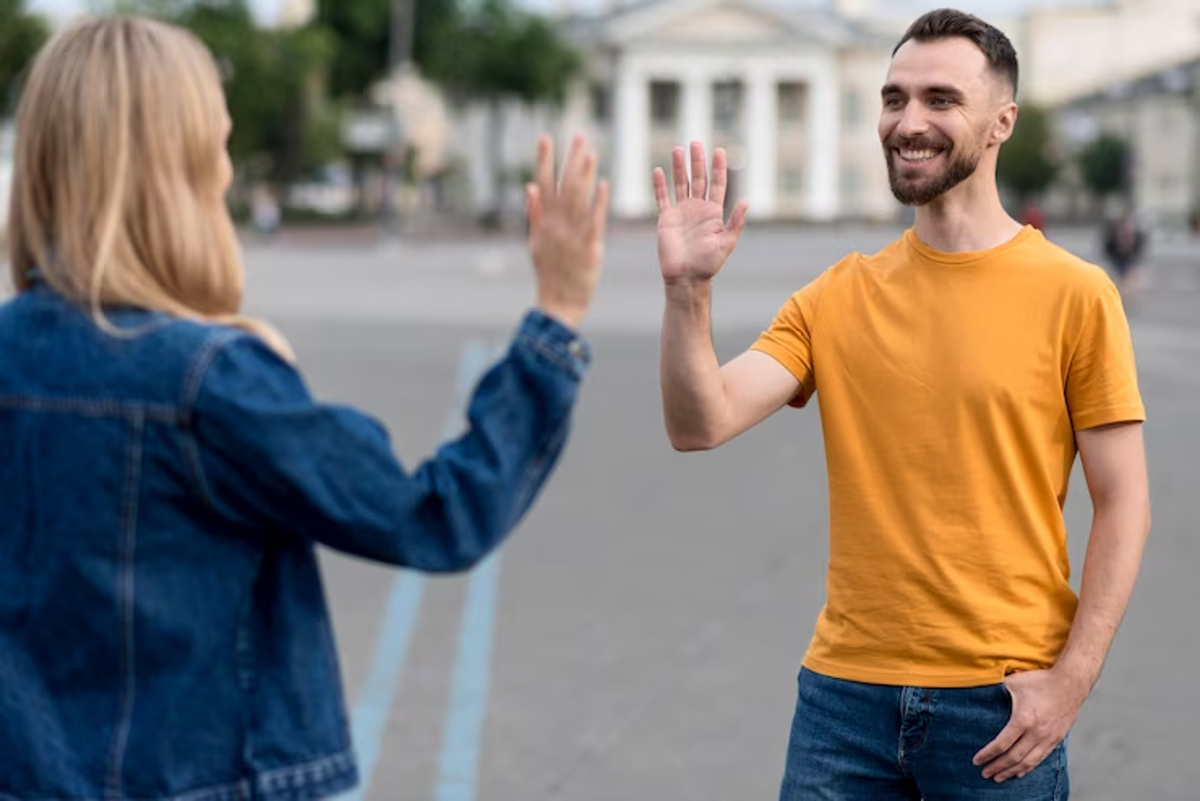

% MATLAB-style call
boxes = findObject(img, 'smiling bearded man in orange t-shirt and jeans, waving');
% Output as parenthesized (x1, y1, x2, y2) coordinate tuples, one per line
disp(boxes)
(654, 10, 1150, 801)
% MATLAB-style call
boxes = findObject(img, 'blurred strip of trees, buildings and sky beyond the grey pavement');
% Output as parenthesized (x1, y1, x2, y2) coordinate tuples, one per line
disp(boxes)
(0, 0, 1200, 237)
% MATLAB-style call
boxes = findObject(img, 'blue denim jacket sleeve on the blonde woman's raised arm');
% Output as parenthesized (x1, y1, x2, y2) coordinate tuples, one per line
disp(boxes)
(191, 312, 589, 572)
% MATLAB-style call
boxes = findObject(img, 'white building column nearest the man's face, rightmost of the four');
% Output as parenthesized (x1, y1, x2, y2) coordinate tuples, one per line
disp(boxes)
(805, 59, 841, 219)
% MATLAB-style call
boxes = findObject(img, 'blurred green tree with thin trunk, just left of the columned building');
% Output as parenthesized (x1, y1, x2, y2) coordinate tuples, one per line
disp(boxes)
(428, 0, 582, 224)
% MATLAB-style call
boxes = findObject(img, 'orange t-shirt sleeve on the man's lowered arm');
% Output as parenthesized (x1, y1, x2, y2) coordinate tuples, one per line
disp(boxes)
(1067, 283, 1146, 430)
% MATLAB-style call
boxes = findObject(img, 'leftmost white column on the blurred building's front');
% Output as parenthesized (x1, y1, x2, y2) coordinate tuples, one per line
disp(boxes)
(611, 65, 654, 217)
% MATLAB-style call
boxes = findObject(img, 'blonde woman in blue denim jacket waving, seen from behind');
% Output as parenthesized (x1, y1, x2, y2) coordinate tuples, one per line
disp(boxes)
(0, 18, 608, 801)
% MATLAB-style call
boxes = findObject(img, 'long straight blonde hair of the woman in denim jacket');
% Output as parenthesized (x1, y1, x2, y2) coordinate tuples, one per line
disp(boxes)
(8, 17, 293, 360)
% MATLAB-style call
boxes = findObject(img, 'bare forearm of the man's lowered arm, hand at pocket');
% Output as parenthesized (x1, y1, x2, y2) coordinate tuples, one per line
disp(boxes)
(1055, 501, 1150, 692)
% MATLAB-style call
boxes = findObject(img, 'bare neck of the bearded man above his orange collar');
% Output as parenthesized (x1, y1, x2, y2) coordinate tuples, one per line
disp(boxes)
(913, 181, 1024, 253)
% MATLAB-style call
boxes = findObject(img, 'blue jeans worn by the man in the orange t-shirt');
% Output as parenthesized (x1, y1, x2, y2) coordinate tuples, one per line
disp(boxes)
(779, 668, 1070, 801)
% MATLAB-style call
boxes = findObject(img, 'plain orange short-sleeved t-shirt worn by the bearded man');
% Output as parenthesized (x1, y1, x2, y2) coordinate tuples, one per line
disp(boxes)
(754, 227, 1145, 687)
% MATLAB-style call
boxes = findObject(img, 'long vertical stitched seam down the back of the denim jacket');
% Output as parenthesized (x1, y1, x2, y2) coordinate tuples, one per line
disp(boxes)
(107, 416, 144, 796)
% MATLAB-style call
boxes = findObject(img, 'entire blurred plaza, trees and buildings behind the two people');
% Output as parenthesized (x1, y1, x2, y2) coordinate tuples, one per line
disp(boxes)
(0, 0, 1200, 801)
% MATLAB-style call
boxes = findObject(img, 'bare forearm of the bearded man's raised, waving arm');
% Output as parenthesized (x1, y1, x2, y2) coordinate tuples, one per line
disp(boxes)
(659, 282, 728, 451)
